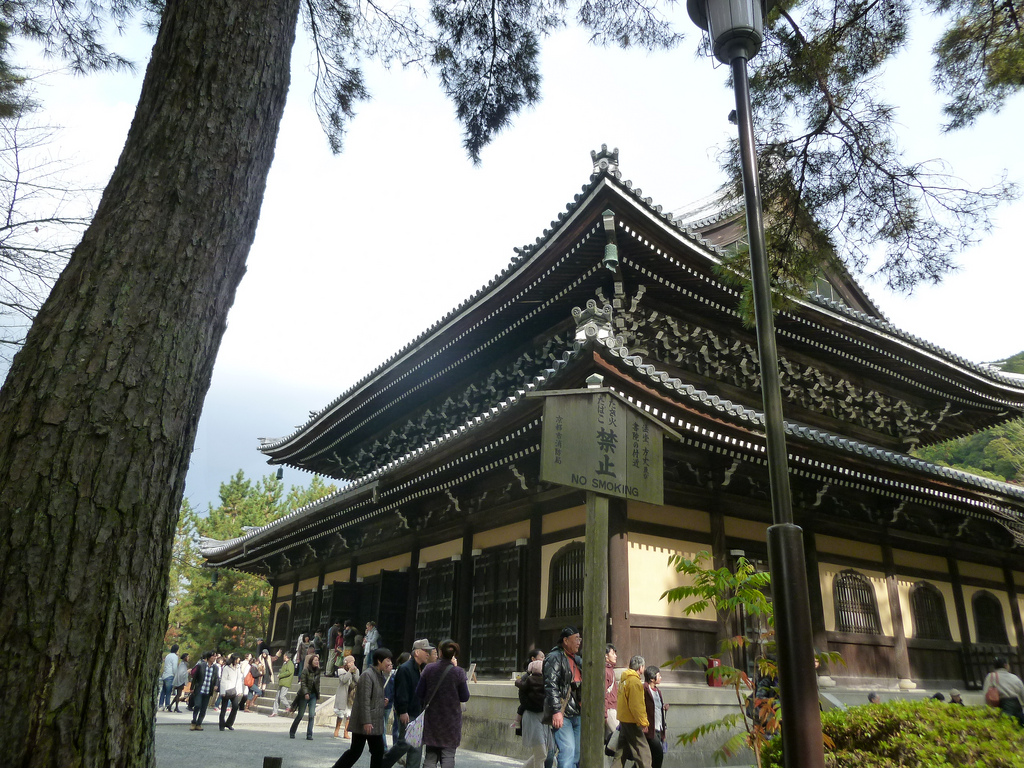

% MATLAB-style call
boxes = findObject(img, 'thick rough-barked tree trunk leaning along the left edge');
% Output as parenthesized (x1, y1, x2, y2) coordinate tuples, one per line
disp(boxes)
(0, 0, 299, 768)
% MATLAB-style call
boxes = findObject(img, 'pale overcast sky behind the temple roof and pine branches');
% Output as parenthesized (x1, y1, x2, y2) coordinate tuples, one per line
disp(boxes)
(9, 3, 1024, 509)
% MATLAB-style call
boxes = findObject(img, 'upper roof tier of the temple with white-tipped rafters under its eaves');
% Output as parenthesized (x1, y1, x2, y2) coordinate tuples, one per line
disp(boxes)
(253, 146, 1024, 501)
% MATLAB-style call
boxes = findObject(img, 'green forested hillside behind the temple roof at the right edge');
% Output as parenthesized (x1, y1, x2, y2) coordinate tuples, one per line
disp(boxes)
(913, 352, 1024, 483)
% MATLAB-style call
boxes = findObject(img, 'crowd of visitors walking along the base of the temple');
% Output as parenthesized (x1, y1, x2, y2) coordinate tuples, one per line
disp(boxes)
(158, 621, 1024, 768)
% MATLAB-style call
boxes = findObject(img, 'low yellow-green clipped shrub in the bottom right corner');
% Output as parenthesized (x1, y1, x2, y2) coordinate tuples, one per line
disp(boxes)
(763, 700, 1024, 768)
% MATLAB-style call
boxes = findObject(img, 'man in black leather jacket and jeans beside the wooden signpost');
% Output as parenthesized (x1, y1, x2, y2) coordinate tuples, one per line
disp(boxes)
(544, 627, 583, 768)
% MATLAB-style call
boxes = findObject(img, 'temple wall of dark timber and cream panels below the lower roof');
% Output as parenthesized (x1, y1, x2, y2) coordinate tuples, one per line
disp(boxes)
(271, 501, 1024, 688)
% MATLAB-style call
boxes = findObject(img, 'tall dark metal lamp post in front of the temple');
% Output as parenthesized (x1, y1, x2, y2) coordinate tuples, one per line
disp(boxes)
(686, 0, 824, 768)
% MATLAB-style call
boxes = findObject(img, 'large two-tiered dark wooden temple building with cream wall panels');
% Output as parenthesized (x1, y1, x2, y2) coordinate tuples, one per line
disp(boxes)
(203, 148, 1024, 690)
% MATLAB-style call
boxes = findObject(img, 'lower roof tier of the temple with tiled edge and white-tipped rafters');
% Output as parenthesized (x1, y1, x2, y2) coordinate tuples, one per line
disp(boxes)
(207, 301, 1024, 569)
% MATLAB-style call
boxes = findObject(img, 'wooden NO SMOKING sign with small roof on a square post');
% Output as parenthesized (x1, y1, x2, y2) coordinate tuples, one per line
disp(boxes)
(534, 382, 679, 768)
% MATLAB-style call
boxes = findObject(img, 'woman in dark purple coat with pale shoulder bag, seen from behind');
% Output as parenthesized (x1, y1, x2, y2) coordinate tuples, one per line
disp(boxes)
(406, 640, 469, 768)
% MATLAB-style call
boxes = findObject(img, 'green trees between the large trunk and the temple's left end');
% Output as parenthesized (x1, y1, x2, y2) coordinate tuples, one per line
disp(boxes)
(166, 470, 334, 653)
